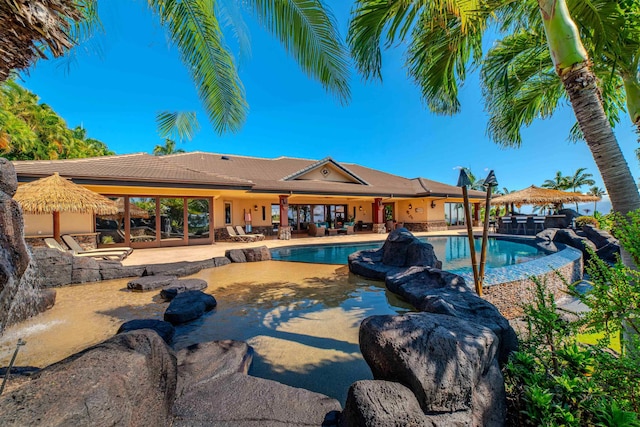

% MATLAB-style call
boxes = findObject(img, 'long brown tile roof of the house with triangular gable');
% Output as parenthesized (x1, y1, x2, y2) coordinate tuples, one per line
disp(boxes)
(13, 151, 484, 199)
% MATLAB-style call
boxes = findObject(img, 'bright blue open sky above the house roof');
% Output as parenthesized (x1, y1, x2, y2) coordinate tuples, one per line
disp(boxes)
(17, 1, 640, 206)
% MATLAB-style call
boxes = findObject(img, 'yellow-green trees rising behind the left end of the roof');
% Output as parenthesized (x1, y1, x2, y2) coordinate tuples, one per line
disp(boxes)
(0, 81, 113, 160)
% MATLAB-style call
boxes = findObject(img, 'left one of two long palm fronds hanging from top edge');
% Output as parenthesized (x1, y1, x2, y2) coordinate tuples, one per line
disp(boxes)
(149, 0, 247, 133)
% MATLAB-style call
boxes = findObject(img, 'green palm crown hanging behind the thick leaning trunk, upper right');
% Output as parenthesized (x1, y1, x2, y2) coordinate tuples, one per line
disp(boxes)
(481, 0, 640, 146)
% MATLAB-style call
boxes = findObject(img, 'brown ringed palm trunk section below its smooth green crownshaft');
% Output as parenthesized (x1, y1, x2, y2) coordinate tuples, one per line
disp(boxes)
(561, 62, 640, 214)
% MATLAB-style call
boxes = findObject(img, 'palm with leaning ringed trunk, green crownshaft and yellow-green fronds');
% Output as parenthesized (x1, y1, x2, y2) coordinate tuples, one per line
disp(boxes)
(348, 0, 640, 217)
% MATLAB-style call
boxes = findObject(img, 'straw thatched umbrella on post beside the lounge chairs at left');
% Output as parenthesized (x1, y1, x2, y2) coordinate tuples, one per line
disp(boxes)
(13, 172, 118, 241)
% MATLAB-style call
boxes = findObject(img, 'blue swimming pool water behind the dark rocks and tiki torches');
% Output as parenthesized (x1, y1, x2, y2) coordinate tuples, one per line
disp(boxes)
(271, 236, 548, 272)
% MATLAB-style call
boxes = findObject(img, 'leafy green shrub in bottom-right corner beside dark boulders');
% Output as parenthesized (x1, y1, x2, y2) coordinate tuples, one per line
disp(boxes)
(505, 281, 640, 427)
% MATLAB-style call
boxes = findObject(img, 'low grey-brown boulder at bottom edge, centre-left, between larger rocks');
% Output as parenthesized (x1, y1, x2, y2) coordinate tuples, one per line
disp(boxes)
(173, 373, 341, 427)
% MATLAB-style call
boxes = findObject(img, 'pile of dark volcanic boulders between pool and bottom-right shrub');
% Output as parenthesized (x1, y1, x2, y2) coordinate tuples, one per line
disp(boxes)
(341, 229, 518, 426)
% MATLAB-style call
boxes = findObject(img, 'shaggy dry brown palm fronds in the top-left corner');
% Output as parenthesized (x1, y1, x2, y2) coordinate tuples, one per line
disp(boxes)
(0, 0, 83, 82)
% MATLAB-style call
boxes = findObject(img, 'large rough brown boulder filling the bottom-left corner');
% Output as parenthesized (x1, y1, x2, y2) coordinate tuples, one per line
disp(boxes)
(0, 330, 177, 426)
